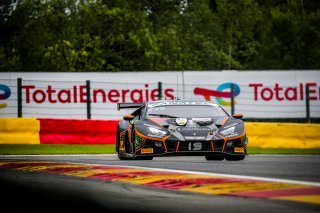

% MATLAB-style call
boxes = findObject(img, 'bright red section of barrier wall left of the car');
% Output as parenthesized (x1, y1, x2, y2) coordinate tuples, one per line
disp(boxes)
(38, 119, 119, 144)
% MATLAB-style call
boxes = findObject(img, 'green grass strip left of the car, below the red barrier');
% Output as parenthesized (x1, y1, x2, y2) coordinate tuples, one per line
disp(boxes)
(0, 144, 116, 155)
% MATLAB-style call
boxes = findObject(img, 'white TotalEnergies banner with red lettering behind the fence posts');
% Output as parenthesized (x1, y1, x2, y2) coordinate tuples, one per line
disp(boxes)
(0, 71, 320, 119)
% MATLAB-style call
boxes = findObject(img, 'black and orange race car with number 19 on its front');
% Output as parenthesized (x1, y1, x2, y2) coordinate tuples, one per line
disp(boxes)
(116, 100, 248, 160)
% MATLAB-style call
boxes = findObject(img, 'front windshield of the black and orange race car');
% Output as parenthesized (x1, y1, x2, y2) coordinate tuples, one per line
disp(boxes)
(147, 105, 227, 118)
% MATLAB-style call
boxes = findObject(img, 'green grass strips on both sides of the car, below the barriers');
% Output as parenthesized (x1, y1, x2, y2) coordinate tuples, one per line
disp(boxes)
(0, 144, 320, 155)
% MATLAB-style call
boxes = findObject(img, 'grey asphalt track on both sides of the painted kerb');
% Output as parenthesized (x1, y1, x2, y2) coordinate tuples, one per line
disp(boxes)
(0, 155, 320, 213)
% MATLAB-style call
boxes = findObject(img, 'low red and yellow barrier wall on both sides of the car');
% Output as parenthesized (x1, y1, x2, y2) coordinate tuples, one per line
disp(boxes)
(0, 118, 320, 149)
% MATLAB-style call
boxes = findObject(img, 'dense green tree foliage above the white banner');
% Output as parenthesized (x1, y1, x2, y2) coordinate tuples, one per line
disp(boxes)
(0, 0, 320, 72)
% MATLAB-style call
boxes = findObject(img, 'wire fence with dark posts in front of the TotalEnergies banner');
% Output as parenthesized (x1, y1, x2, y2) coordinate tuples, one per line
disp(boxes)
(0, 78, 320, 122)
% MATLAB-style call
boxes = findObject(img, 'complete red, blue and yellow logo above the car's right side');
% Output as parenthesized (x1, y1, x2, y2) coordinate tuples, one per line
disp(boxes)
(193, 82, 240, 106)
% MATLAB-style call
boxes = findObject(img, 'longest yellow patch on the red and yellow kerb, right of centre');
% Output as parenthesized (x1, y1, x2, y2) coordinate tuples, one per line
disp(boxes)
(181, 182, 306, 194)
